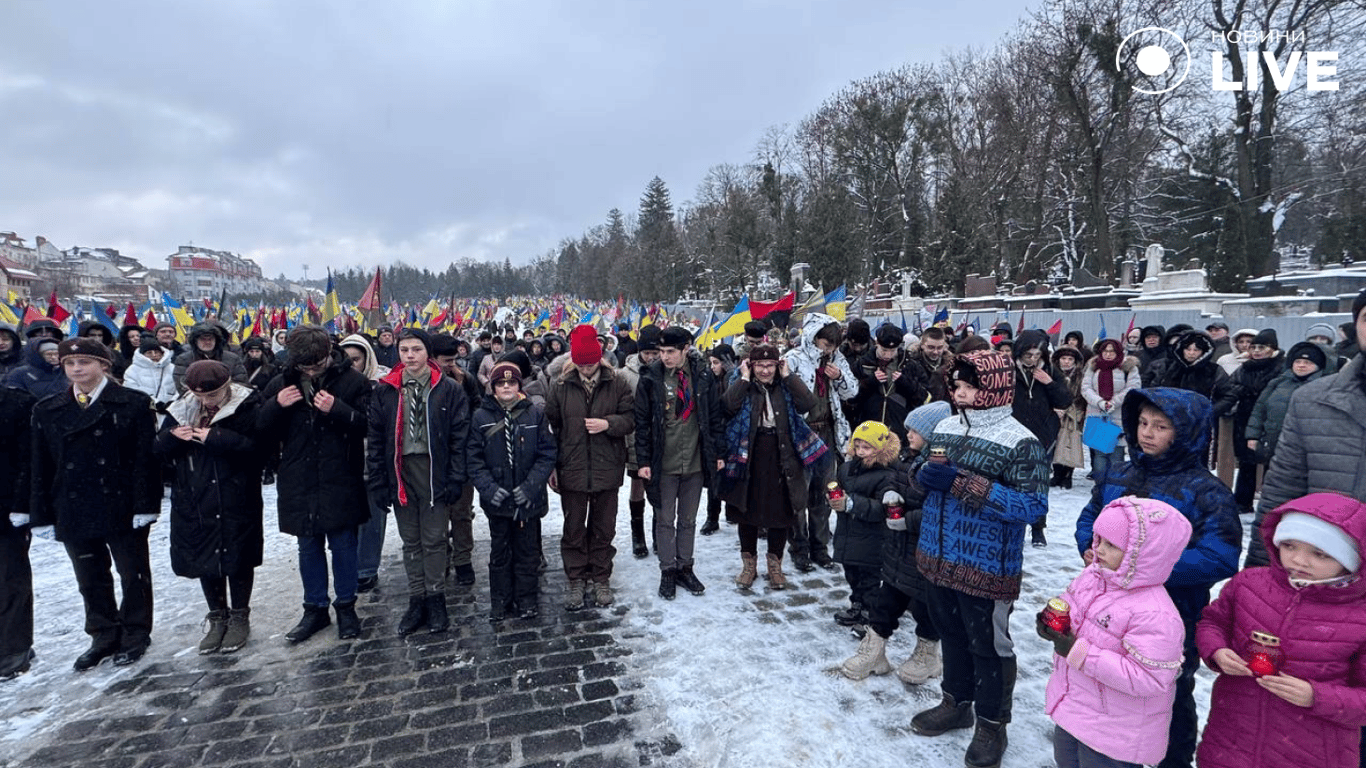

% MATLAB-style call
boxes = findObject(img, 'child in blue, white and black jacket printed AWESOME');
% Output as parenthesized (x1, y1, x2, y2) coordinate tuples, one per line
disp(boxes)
(911, 351, 1052, 767)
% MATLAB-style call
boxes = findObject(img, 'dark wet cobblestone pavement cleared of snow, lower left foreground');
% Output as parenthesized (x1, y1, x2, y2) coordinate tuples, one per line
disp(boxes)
(0, 537, 686, 768)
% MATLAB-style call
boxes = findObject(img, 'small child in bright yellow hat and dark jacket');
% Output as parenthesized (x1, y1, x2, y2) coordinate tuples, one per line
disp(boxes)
(831, 421, 902, 626)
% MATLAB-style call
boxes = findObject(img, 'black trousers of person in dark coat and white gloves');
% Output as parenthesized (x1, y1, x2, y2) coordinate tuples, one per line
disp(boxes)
(63, 527, 152, 650)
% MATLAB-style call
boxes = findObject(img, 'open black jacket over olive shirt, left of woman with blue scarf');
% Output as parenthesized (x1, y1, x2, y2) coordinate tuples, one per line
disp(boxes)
(635, 353, 732, 508)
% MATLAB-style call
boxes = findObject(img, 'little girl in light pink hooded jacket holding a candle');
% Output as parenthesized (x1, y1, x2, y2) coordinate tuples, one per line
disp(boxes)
(1035, 496, 1191, 768)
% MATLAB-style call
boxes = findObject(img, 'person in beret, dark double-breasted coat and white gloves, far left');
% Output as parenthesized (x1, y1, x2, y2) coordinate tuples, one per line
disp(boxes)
(30, 338, 161, 672)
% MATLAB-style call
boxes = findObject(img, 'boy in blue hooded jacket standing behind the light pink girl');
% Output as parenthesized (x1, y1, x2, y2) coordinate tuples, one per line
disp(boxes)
(1076, 387, 1243, 768)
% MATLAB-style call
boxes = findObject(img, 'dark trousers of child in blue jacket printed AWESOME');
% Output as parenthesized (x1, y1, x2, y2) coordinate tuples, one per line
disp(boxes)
(926, 584, 1015, 723)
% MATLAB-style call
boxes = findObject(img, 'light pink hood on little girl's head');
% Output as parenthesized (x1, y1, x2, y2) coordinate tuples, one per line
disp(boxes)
(1087, 496, 1191, 589)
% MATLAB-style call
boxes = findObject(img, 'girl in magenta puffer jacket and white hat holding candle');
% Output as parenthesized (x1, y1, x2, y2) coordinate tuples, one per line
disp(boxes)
(1195, 493, 1366, 768)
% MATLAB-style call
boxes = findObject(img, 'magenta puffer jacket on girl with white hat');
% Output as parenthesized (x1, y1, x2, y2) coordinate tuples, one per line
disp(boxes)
(1195, 493, 1366, 768)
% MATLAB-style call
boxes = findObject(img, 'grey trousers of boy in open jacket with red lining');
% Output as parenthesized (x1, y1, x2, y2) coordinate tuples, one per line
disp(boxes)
(393, 454, 451, 597)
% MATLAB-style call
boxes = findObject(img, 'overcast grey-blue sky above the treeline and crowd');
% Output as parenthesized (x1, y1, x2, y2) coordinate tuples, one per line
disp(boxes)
(0, 0, 1034, 277)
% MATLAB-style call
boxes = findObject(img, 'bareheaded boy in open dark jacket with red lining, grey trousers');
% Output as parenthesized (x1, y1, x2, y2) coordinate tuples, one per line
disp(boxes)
(365, 328, 470, 637)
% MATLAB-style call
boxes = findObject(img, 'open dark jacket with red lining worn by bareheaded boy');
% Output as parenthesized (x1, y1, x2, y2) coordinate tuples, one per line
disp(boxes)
(365, 362, 470, 508)
